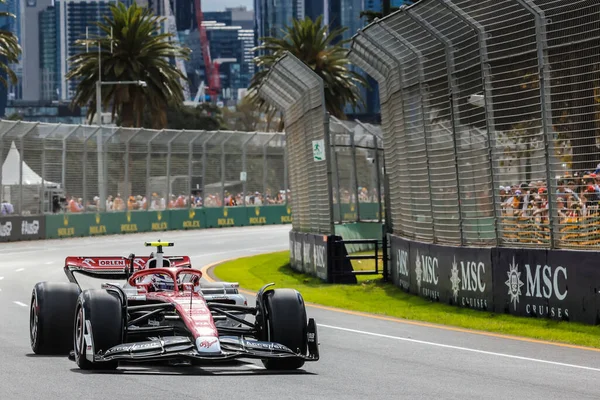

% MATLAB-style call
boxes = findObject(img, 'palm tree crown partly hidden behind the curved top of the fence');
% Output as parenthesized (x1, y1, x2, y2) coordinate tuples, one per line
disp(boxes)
(249, 16, 367, 119)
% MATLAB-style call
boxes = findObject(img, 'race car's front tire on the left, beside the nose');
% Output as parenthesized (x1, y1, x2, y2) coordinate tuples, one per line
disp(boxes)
(73, 289, 124, 370)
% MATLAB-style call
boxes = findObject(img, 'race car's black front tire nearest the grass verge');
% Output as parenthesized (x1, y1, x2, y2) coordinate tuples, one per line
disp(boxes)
(262, 289, 308, 370)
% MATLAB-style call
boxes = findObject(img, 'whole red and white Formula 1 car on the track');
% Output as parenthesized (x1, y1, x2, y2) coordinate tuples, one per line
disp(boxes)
(30, 241, 319, 370)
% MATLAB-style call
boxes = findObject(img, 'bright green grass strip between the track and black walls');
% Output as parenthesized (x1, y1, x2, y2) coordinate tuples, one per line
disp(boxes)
(214, 251, 600, 348)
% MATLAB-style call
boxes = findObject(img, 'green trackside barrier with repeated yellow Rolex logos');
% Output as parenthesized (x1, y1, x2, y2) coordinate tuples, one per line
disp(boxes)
(40, 206, 292, 241)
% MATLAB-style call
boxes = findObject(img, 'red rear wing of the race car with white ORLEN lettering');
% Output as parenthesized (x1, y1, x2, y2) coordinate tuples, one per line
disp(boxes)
(64, 255, 192, 284)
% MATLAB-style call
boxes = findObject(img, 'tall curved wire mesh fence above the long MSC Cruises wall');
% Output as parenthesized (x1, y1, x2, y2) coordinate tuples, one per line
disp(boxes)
(350, 0, 600, 249)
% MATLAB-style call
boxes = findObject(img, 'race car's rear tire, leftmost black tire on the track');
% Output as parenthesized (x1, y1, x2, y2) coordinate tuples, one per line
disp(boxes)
(29, 282, 81, 355)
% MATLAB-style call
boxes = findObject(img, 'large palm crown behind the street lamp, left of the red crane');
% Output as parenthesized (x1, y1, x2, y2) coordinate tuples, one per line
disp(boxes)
(66, 2, 190, 129)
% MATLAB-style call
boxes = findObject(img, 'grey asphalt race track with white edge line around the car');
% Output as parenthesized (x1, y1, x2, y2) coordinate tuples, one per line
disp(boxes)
(0, 227, 600, 400)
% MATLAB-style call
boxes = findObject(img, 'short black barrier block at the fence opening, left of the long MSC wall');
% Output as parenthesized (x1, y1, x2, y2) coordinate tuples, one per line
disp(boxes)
(290, 231, 357, 283)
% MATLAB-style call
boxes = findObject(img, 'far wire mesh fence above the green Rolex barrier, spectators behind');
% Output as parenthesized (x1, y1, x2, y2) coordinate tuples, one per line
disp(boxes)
(0, 121, 291, 215)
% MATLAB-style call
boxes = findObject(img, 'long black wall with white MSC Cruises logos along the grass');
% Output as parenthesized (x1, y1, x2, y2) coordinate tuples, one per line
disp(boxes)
(390, 235, 600, 324)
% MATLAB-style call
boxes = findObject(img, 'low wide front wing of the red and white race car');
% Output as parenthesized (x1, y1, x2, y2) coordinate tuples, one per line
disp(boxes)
(85, 318, 319, 363)
